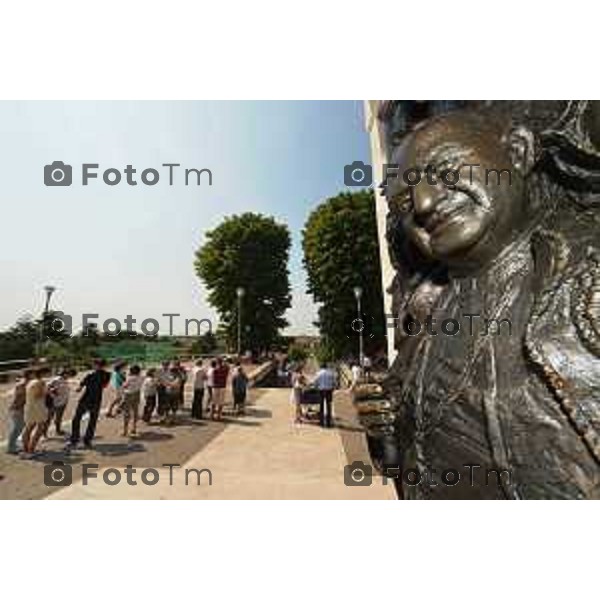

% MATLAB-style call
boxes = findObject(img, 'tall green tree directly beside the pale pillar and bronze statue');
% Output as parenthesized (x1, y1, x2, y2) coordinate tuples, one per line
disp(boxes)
(302, 190, 385, 358)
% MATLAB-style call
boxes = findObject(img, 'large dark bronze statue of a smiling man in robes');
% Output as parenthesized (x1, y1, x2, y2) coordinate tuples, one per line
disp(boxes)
(384, 102, 600, 499)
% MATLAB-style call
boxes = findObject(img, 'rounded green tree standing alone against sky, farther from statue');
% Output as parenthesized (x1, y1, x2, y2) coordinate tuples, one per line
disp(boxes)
(194, 213, 291, 351)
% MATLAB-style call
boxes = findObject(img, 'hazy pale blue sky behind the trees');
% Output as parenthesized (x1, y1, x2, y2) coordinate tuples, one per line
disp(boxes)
(0, 101, 369, 333)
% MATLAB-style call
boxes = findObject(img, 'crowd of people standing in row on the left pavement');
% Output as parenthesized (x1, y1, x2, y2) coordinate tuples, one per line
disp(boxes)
(7, 358, 249, 458)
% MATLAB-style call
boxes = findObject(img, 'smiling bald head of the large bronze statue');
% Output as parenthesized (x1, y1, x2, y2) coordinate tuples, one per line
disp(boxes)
(387, 113, 526, 267)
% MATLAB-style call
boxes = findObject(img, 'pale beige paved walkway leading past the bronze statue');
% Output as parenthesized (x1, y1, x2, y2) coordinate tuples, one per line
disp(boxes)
(49, 389, 395, 499)
